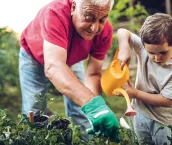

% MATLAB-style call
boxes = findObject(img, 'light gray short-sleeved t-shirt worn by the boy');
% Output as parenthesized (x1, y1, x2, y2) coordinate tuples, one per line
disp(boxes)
(131, 34, 172, 125)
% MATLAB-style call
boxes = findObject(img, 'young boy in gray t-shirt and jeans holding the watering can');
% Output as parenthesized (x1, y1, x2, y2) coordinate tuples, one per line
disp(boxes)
(117, 13, 172, 145)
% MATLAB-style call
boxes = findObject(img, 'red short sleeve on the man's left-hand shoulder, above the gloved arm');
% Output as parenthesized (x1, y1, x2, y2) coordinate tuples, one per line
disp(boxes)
(40, 9, 68, 49)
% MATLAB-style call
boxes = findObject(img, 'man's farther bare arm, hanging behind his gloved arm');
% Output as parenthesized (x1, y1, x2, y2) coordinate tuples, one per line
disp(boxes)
(84, 56, 103, 96)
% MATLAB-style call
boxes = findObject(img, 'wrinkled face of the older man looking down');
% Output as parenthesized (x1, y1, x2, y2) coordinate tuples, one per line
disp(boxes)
(71, 0, 110, 40)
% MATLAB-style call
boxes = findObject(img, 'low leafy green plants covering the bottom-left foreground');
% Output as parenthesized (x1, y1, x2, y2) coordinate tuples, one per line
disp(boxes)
(0, 110, 109, 145)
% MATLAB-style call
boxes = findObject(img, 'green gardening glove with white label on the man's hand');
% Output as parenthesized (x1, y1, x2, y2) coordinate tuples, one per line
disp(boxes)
(81, 96, 119, 143)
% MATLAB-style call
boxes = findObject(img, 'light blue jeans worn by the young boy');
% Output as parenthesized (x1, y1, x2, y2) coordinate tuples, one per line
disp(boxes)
(134, 114, 172, 145)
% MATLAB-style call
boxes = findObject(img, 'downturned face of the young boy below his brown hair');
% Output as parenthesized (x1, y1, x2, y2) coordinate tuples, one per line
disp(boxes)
(144, 42, 172, 66)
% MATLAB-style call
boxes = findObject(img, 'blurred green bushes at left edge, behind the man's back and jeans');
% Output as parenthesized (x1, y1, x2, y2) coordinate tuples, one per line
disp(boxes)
(0, 28, 21, 119)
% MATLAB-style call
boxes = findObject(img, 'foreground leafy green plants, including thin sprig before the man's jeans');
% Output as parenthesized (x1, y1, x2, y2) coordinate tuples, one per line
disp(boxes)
(0, 94, 138, 145)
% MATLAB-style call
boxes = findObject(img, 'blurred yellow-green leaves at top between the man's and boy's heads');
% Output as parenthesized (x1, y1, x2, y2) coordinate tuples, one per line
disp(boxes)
(109, 0, 148, 32)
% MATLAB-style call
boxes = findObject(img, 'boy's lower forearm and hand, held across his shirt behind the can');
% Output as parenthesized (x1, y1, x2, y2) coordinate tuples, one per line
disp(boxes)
(126, 82, 172, 107)
